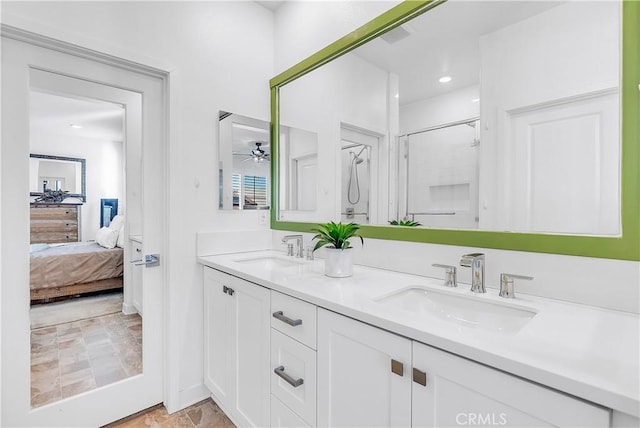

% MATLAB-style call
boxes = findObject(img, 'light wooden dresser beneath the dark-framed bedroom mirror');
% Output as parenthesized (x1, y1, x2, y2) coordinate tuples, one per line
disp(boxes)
(31, 203, 82, 244)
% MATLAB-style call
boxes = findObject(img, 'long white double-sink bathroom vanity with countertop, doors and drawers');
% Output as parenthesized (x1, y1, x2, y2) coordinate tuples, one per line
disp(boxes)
(199, 250, 640, 427)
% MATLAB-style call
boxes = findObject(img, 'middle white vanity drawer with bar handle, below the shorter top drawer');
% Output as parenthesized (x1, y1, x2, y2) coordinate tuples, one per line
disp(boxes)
(271, 328, 316, 425)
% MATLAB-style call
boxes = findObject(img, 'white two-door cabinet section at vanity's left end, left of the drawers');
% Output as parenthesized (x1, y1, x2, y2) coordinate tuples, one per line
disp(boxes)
(204, 267, 271, 427)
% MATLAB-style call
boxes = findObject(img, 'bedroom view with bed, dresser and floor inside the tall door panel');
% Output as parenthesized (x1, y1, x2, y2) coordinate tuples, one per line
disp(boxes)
(29, 88, 142, 407)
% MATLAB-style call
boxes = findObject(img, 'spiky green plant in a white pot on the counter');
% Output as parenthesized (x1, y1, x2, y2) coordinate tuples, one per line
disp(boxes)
(311, 222, 364, 278)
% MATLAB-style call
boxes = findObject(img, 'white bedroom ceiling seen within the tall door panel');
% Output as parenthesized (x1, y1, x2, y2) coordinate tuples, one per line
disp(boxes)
(29, 91, 124, 141)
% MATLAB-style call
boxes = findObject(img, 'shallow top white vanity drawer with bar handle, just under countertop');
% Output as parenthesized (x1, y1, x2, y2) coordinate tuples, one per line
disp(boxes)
(271, 291, 317, 349)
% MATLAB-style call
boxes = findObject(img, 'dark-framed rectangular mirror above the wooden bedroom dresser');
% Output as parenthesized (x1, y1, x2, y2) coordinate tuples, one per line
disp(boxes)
(29, 154, 87, 202)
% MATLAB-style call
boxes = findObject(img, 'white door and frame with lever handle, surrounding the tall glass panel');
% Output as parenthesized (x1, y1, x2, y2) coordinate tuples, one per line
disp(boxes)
(0, 32, 168, 427)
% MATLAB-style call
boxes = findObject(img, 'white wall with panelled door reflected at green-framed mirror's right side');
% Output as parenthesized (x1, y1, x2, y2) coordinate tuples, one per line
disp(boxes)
(480, 1, 620, 235)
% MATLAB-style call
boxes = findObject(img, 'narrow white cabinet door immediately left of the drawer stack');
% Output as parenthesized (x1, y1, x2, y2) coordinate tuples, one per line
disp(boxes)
(230, 277, 271, 427)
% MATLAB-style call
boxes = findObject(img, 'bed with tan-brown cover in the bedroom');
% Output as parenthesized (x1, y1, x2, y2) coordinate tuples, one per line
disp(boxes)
(30, 242, 123, 301)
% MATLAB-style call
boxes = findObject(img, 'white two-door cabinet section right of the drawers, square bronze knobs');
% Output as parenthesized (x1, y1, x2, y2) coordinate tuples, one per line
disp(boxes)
(318, 309, 610, 427)
